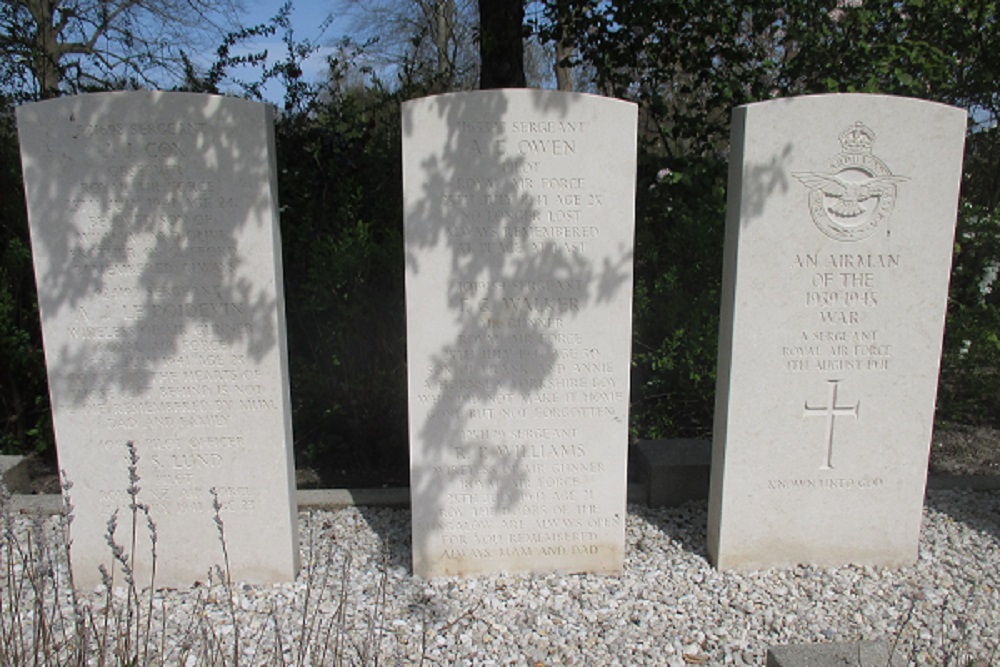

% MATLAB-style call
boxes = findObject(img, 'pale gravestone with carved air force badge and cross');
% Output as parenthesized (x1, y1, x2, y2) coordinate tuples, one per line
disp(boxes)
(708, 95, 966, 569)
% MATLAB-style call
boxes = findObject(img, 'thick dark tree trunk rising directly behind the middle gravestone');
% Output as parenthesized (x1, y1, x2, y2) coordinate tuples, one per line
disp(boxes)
(479, 0, 527, 90)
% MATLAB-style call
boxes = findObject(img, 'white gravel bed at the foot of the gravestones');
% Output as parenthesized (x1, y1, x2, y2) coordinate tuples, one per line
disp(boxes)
(5, 491, 1000, 667)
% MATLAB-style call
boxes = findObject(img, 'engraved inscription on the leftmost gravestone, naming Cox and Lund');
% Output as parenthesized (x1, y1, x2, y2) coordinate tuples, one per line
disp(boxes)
(30, 105, 280, 515)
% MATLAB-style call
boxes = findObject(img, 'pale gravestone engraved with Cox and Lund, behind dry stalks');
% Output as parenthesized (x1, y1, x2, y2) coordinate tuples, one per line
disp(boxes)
(17, 92, 298, 586)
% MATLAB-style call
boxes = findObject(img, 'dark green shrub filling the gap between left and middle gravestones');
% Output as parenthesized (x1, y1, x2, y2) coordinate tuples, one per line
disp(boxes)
(276, 81, 408, 484)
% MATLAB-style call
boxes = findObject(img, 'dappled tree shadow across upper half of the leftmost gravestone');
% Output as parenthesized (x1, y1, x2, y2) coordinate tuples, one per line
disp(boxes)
(22, 92, 286, 406)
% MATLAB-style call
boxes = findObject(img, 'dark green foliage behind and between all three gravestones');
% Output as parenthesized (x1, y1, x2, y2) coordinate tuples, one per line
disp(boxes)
(0, 0, 1000, 486)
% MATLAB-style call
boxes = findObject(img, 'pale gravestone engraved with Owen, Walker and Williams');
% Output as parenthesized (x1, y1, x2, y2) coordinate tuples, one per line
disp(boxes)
(403, 90, 636, 576)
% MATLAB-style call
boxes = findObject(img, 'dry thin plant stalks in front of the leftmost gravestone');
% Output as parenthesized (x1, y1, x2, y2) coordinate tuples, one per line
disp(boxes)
(0, 442, 388, 667)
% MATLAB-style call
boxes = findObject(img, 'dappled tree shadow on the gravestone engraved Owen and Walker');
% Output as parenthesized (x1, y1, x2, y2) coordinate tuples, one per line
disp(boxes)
(403, 91, 632, 569)
